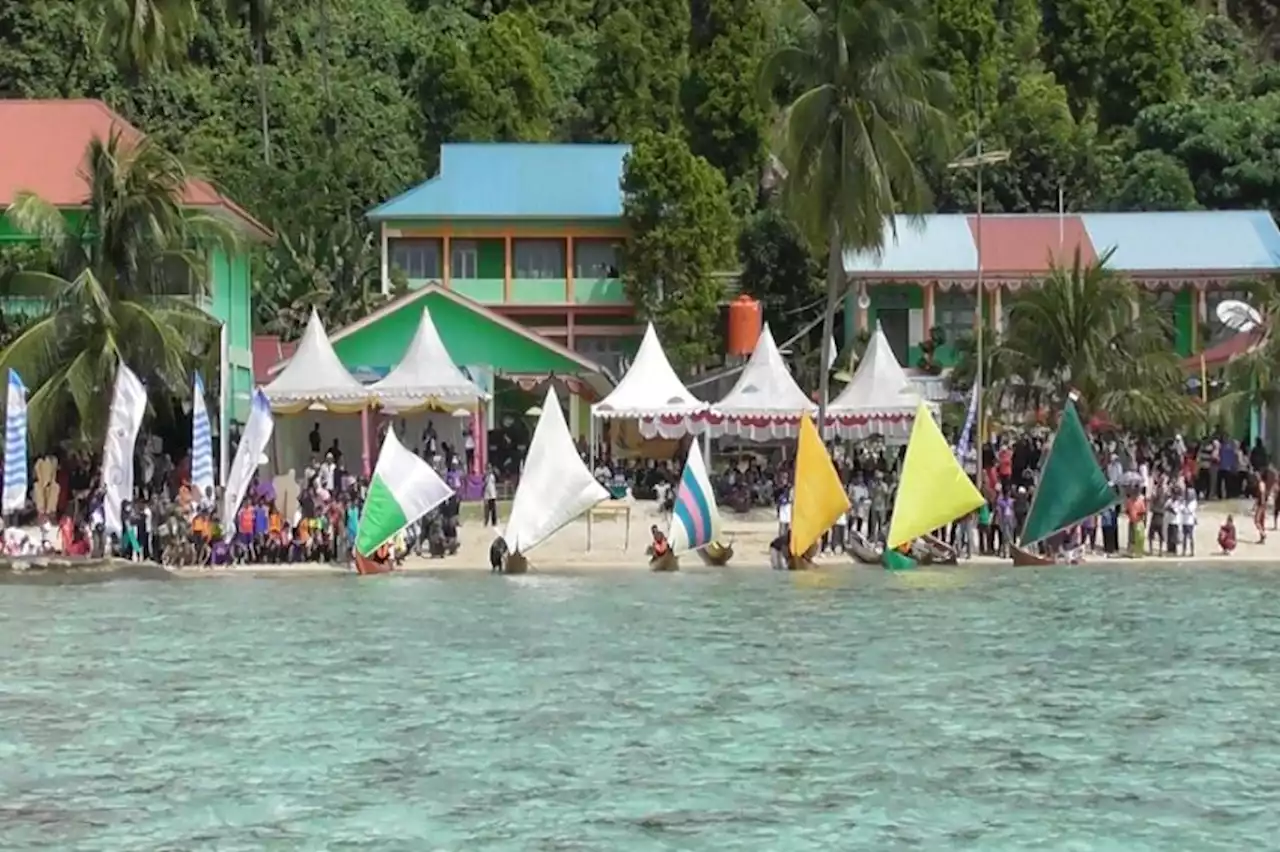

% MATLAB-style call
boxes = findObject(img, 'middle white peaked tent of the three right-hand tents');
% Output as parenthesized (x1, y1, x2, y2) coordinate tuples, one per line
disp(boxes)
(709, 324, 818, 441)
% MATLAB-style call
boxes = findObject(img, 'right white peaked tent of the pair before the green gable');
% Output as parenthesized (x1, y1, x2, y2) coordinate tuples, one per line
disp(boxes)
(369, 307, 489, 413)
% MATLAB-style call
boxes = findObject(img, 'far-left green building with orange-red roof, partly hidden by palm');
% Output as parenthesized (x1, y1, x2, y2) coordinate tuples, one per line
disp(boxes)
(0, 100, 271, 422)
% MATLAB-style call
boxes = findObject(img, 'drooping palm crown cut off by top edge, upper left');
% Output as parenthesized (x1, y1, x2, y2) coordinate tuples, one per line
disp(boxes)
(86, 0, 200, 74)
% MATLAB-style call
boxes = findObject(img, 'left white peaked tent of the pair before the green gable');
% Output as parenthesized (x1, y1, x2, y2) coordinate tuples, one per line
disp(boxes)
(262, 310, 370, 414)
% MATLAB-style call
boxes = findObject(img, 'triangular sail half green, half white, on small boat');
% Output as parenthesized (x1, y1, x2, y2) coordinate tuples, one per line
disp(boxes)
(356, 429, 453, 556)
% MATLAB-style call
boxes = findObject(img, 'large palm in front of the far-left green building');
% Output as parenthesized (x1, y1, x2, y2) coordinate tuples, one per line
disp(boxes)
(0, 133, 236, 446)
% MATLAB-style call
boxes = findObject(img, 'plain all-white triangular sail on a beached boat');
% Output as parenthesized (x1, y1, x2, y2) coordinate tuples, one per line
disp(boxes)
(504, 389, 609, 554)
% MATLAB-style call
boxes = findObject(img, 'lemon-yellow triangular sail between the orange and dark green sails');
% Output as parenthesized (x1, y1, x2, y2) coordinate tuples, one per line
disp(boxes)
(886, 403, 983, 549)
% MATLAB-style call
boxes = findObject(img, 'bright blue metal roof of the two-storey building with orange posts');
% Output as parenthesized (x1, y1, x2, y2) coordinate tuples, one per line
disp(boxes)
(369, 142, 631, 220)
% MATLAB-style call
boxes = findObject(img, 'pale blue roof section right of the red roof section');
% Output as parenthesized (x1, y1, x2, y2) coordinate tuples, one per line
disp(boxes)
(1080, 210, 1280, 272)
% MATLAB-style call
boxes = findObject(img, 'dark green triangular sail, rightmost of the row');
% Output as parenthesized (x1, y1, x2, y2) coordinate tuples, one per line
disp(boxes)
(1021, 400, 1117, 545)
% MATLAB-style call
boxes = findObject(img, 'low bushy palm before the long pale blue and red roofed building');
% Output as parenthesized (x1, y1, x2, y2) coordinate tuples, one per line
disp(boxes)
(952, 245, 1203, 430)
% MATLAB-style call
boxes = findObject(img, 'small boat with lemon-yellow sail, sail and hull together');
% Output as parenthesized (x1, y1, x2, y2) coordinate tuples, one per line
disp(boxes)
(882, 402, 986, 571)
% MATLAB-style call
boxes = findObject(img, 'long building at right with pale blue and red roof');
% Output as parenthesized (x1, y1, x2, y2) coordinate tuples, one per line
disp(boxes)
(845, 211, 1280, 367)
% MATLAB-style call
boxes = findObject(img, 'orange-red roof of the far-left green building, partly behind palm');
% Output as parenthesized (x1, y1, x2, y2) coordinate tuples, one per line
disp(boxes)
(0, 100, 271, 238)
